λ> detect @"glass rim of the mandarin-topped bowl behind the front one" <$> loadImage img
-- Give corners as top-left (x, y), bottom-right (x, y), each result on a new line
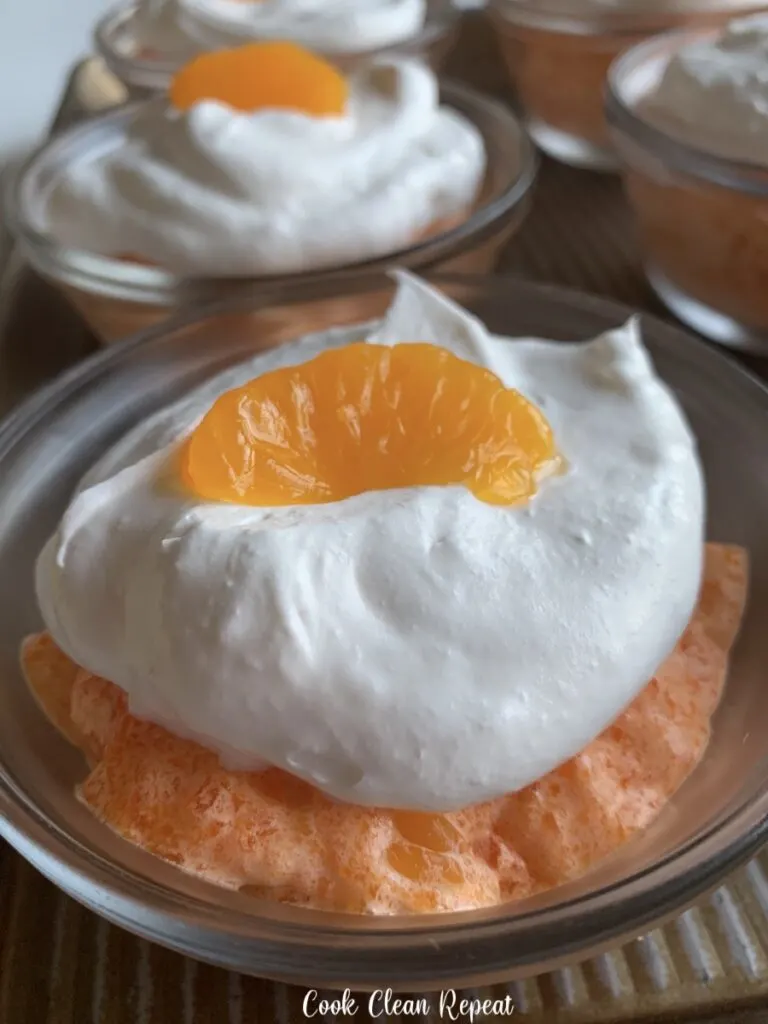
top-left (4, 79), bottom-right (539, 306)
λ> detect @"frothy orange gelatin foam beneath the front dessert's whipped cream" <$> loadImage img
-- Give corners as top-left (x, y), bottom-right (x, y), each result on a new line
top-left (22, 545), bottom-right (748, 913)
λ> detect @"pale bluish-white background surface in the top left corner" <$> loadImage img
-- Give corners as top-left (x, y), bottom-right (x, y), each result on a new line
top-left (0, 0), bottom-right (109, 166)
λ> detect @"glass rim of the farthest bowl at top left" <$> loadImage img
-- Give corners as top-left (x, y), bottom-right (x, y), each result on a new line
top-left (93, 0), bottom-right (462, 89)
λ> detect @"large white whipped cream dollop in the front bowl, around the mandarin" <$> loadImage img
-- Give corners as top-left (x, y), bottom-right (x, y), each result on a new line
top-left (37, 276), bottom-right (703, 810)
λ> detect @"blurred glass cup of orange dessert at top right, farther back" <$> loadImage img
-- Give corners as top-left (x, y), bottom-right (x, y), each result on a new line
top-left (490, 0), bottom-right (760, 171)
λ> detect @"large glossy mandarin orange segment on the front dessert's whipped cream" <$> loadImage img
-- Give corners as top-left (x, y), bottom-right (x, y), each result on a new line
top-left (181, 342), bottom-right (555, 506)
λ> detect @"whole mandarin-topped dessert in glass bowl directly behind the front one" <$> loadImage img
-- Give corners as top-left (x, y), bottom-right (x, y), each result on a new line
top-left (6, 44), bottom-right (537, 341)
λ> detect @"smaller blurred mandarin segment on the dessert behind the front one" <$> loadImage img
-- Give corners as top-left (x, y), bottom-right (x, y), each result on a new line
top-left (170, 42), bottom-right (348, 118)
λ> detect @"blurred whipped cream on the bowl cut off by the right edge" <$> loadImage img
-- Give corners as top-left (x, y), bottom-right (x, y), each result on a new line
top-left (639, 13), bottom-right (768, 167)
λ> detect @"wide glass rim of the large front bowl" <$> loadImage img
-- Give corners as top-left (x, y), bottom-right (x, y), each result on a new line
top-left (0, 274), bottom-right (768, 987)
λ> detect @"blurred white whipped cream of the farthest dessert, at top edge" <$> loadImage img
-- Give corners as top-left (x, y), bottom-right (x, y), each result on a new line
top-left (135, 0), bottom-right (427, 55)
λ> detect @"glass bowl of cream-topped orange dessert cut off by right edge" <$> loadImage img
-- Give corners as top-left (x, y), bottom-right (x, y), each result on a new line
top-left (606, 15), bottom-right (768, 355)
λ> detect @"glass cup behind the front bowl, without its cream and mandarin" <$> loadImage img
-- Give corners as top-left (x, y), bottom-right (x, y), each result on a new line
top-left (6, 83), bottom-right (538, 342)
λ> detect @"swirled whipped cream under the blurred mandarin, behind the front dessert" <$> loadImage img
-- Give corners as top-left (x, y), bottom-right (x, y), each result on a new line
top-left (44, 58), bottom-right (485, 276)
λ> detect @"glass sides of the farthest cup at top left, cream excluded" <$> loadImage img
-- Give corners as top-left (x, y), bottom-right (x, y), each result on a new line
top-left (93, 0), bottom-right (461, 98)
